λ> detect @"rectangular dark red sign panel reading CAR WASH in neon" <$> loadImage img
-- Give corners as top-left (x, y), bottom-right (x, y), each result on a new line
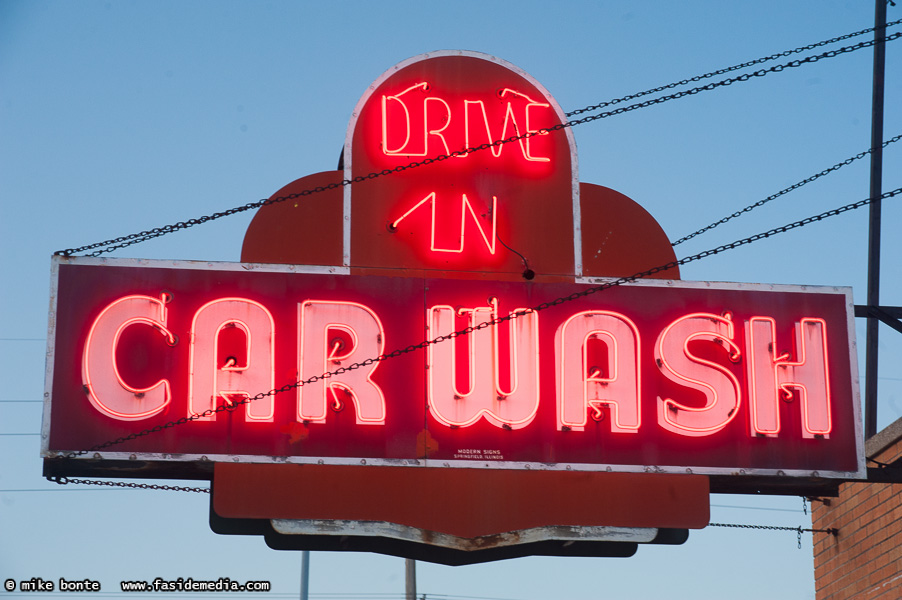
top-left (44, 258), bottom-right (863, 477)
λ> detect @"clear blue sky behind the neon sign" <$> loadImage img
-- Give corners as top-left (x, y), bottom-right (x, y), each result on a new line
top-left (0, 0), bottom-right (902, 600)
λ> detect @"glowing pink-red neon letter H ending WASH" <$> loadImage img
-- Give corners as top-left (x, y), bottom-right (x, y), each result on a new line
top-left (746, 317), bottom-right (832, 438)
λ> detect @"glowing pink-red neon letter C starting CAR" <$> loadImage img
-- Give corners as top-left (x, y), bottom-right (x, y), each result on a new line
top-left (81, 294), bottom-right (176, 421)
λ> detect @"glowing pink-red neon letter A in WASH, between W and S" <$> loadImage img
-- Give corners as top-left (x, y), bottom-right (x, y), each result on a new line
top-left (554, 310), bottom-right (641, 433)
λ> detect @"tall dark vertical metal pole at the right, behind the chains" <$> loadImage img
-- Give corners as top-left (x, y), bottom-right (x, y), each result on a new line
top-left (864, 0), bottom-right (886, 438)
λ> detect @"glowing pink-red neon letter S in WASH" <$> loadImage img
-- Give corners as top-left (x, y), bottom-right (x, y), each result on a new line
top-left (655, 313), bottom-right (741, 436)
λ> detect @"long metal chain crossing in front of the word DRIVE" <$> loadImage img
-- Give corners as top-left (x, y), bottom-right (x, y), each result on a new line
top-left (55, 28), bottom-right (902, 257)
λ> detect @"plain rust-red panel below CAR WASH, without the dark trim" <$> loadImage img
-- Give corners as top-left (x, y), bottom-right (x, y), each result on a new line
top-left (213, 463), bottom-right (709, 539)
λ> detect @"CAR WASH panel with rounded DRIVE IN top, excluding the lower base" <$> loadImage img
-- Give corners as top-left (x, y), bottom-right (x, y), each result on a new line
top-left (43, 51), bottom-right (864, 478)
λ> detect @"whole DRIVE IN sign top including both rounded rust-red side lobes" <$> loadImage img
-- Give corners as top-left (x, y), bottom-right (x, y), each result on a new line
top-left (241, 50), bottom-right (680, 282)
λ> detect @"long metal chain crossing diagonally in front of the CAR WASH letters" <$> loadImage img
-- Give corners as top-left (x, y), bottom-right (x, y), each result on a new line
top-left (51, 188), bottom-right (902, 458)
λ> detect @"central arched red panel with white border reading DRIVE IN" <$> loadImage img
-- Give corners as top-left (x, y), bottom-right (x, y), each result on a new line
top-left (343, 50), bottom-right (582, 277)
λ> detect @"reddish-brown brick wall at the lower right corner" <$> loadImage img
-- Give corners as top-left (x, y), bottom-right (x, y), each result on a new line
top-left (812, 419), bottom-right (902, 600)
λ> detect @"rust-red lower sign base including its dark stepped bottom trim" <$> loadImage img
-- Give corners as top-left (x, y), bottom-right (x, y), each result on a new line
top-left (210, 464), bottom-right (708, 565)
